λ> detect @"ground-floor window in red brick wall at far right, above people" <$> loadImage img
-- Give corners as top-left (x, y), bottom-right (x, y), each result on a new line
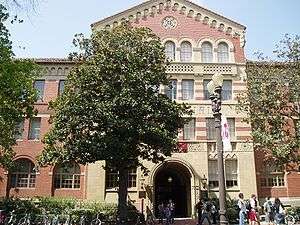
top-left (260, 165), bottom-right (285, 187)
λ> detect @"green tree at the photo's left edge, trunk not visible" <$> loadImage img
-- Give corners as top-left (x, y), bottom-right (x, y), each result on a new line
top-left (0, 4), bottom-right (39, 167)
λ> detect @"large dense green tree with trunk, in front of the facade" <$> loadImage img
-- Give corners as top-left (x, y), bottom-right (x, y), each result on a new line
top-left (40, 25), bottom-right (191, 223)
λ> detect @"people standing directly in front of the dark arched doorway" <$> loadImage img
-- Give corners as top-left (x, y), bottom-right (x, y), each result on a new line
top-left (158, 199), bottom-right (175, 225)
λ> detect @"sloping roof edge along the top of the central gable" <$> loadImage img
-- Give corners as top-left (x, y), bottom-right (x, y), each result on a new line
top-left (90, 0), bottom-right (247, 30)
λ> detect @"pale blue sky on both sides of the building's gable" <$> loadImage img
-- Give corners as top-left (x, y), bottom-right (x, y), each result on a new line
top-left (5, 0), bottom-right (300, 59)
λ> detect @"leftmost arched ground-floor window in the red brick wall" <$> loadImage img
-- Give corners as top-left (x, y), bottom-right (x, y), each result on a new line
top-left (10, 159), bottom-right (36, 188)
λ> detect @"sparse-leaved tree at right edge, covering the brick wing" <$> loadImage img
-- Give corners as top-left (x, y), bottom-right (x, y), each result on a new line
top-left (239, 35), bottom-right (300, 165)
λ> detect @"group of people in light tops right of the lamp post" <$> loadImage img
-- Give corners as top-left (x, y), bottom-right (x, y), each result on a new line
top-left (238, 193), bottom-right (285, 225)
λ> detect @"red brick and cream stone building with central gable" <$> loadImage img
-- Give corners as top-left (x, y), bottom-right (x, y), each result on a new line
top-left (0, 0), bottom-right (300, 217)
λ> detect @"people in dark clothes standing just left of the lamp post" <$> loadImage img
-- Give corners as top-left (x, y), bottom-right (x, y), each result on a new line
top-left (196, 199), bottom-right (218, 225)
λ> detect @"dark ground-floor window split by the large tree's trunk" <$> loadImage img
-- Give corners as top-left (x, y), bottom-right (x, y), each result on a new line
top-left (105, 168), bottom-right (137, 189)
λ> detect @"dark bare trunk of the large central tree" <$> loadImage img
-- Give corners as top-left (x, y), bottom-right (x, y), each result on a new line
top-left (117, 167), bottom-right (128, 225)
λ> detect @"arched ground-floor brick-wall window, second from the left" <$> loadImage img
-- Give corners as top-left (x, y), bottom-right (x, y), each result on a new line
top-left (54, 163), bottom-right (81, 189)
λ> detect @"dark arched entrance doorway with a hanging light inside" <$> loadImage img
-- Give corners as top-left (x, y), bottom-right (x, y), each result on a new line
top-left (154, 162), bottom-right (191, 218)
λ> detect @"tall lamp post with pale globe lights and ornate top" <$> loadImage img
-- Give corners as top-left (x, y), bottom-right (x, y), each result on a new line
top-left (207, 74), bottom-right (228, 225)
